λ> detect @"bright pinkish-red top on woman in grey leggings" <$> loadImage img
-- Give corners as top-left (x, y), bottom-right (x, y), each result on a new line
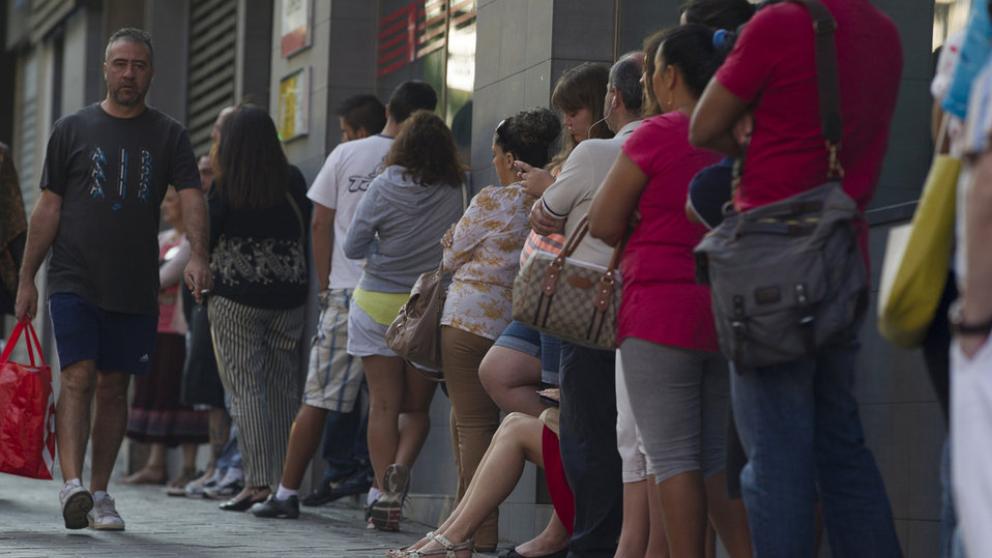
top-left (617, 112), bottom-right (720, 352)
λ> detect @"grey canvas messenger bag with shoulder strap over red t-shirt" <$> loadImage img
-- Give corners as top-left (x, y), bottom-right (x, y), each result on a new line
top-left (695, 0), bottom-right (868, 369)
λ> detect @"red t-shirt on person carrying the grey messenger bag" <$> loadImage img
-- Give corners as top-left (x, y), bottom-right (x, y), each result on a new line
top-left (716, 0), bottom-right (902, 221)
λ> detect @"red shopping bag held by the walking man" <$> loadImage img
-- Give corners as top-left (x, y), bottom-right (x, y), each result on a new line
top-left (0, 321), bottom-right (55, 480)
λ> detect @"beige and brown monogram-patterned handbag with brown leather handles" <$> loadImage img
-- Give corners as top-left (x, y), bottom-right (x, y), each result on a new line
top-left (513, 218), bottom-right (623, 350)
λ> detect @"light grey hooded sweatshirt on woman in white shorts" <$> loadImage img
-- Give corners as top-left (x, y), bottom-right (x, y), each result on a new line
top-left (344, 165), bottom-right (462, 293)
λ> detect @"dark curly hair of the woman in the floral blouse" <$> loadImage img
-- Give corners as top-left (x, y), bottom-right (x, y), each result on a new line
top-left (493, 108), bottom-right (561, 168)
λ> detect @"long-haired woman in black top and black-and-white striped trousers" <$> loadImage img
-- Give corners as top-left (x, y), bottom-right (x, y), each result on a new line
top-left (202, 106), bottom-right (310, 511)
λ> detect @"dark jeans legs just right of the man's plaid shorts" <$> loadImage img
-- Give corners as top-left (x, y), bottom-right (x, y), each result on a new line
top-left (321, 382), bottom-right (372, 482)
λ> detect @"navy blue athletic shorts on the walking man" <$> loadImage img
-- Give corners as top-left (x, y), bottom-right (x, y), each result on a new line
top-left (48, 293), bottom-right (158, 374)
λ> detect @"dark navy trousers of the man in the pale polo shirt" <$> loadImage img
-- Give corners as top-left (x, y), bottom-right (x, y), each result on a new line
top-left (560, 341), bottom-right (623, 558)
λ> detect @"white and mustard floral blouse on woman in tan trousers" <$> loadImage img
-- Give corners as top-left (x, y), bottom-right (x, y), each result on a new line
top-left (441, 184), bottom-right (534, 340)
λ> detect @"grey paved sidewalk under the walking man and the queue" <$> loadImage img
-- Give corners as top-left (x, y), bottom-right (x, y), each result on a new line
top-left (0, 475), bottom-right (429, 558)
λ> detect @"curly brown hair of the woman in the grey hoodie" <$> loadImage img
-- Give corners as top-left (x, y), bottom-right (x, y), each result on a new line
top-left (385, 110), bottom-right (465, 187)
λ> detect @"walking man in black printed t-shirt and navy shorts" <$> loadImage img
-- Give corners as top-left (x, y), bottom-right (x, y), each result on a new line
top-left (15, 28), bottom-right (211, 530)
